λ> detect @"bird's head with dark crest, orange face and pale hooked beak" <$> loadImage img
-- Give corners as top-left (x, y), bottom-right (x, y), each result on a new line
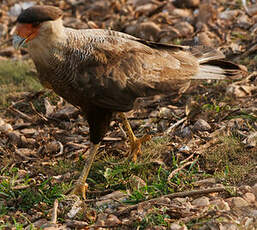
top-left (13, 6), bottom-right (63, 49)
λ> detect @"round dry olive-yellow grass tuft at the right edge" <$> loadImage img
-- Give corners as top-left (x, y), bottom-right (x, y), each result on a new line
top-left (201, 136), bottom-right (257, 185)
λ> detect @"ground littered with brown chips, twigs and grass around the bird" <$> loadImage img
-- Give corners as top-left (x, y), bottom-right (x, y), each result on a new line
top-left (0, 0), bottom-right (257, 230)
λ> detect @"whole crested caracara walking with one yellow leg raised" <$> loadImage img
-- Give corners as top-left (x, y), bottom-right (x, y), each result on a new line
top-left (13, 6), bottom-right (243, 198)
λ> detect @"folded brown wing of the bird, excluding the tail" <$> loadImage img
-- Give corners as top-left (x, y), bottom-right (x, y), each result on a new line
top-left (73, 30), bottom-right (199, 111)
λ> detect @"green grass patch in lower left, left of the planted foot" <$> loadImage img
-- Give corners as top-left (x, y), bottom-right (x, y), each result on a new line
top-left (0, 168), bottom-right (69, 217)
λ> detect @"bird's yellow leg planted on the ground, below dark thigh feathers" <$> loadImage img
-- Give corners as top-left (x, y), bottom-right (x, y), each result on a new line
top-left (71, 143), bottom-right (100, 199)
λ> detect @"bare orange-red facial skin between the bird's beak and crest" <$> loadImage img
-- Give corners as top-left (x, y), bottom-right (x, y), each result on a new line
top-left (16, 23), bottom-right (40, 42)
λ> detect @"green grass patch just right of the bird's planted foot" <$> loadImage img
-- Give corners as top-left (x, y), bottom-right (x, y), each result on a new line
top-left (86, 136), bottom-right (199, 204)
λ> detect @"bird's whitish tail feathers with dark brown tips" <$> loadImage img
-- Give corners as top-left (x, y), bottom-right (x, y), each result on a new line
top-left (191, 47), bottom-right (246, 80)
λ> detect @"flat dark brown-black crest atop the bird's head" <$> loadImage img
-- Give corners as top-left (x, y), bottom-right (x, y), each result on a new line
top-left (17, 6), bottom-right (62, 23)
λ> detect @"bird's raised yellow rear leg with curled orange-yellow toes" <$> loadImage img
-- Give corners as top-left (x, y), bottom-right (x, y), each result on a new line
top-left (120, 113), bottom-right (151, 162)
